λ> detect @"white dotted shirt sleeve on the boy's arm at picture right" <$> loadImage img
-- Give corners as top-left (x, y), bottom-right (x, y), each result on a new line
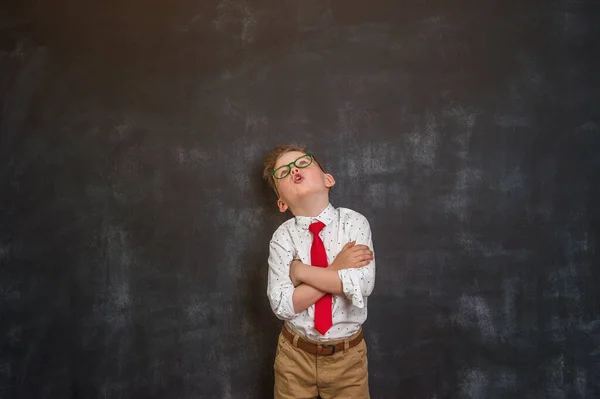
top-left (338, 218), bottom-right (375, 308)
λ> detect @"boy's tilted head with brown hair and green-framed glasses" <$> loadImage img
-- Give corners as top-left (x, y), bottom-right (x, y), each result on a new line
top-left (263, 144), bottom-right (335, 216)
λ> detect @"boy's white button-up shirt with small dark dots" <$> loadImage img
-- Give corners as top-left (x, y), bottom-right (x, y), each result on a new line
top-left (267, 204), bottom-right (375, 341)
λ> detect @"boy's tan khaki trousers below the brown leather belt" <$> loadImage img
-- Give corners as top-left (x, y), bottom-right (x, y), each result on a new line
top-left (274, 324), bottom-right (370, 399)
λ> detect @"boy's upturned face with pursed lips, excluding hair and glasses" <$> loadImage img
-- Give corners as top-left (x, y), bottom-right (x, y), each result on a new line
top-left (275, 151), bottom-right (335, 212)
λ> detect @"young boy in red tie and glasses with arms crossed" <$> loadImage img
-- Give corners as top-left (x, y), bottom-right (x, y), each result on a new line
top-left (263, 145), bottom-right (375, 399)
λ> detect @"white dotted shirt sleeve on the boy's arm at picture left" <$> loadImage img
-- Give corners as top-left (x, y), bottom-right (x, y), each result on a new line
top-left (267, 230), bottom-right (296, 320)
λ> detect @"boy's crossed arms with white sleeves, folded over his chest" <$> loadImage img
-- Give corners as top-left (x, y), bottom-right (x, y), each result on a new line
top-left (267, 221), bottom-right (375, 320)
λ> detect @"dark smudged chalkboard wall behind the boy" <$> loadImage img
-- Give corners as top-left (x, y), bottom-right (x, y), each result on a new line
top-left (0, 0), bottom-right (600, 399)
